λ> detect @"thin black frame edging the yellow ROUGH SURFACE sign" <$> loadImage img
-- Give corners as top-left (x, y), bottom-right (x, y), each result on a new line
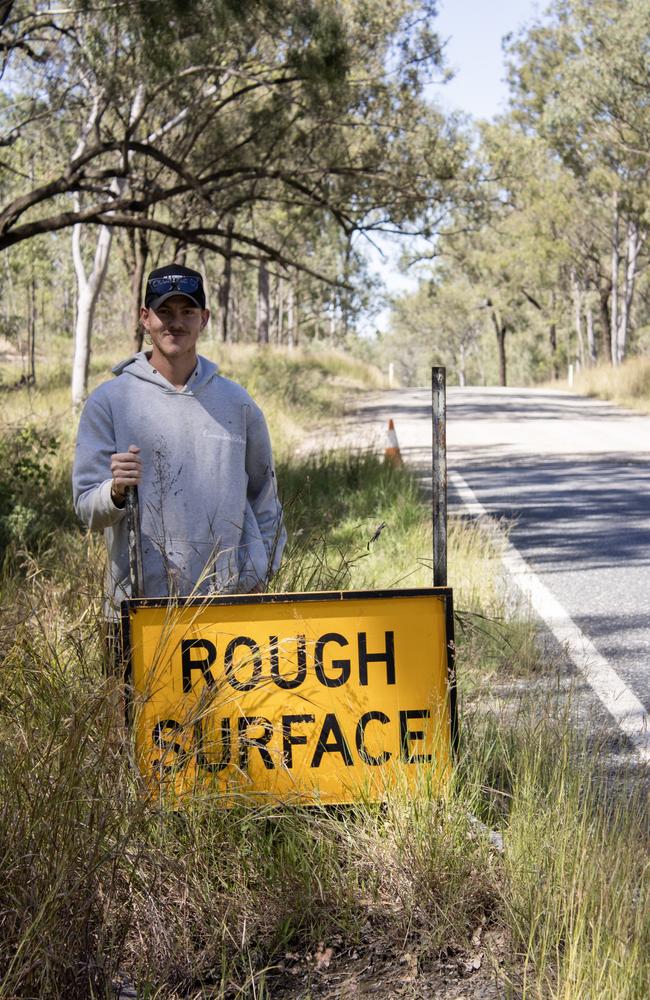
top-left (120, 587), bottom-right (459, 796)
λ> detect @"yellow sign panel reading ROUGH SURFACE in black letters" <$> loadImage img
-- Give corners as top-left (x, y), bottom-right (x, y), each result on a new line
top-left (122, 588), bottom-right (456, 805)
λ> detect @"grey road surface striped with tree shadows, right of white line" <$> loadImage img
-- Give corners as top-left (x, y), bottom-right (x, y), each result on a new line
top-left (350, 388), bottom-right (650, 752)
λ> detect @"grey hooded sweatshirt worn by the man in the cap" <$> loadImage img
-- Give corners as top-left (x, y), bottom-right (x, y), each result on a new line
top-left (72, 353), bottom-right (286, 617)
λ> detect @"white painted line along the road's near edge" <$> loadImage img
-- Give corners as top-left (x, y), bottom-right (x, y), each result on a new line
top-left (449, 472), bottom-right (650, 762)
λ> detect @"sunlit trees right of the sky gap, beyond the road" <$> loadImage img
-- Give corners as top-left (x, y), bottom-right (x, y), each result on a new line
top-left (388, 0), bottom-right (650, 384)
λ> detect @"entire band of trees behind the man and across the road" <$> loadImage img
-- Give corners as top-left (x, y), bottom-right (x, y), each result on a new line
top-left (0, 0), bottom-right (650, 398)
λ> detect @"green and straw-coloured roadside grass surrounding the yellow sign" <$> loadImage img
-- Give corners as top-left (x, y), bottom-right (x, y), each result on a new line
top-left (0, 346), bottom-right (650, 1000)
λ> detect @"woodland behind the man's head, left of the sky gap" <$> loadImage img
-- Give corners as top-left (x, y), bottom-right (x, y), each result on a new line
top-left (0, 0), bottom-right (466, 406)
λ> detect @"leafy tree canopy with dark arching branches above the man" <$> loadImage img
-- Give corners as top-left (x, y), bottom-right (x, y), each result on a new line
top-left (0, 0), bottom-right (464, 402)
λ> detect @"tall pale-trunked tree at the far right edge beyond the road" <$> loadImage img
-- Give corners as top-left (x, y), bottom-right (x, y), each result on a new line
top-left (509, 0), bottom-right (650, 364)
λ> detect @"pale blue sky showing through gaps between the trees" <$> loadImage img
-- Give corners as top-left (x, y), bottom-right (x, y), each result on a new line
top-left (368, 0), bottom-right (546, 329)
